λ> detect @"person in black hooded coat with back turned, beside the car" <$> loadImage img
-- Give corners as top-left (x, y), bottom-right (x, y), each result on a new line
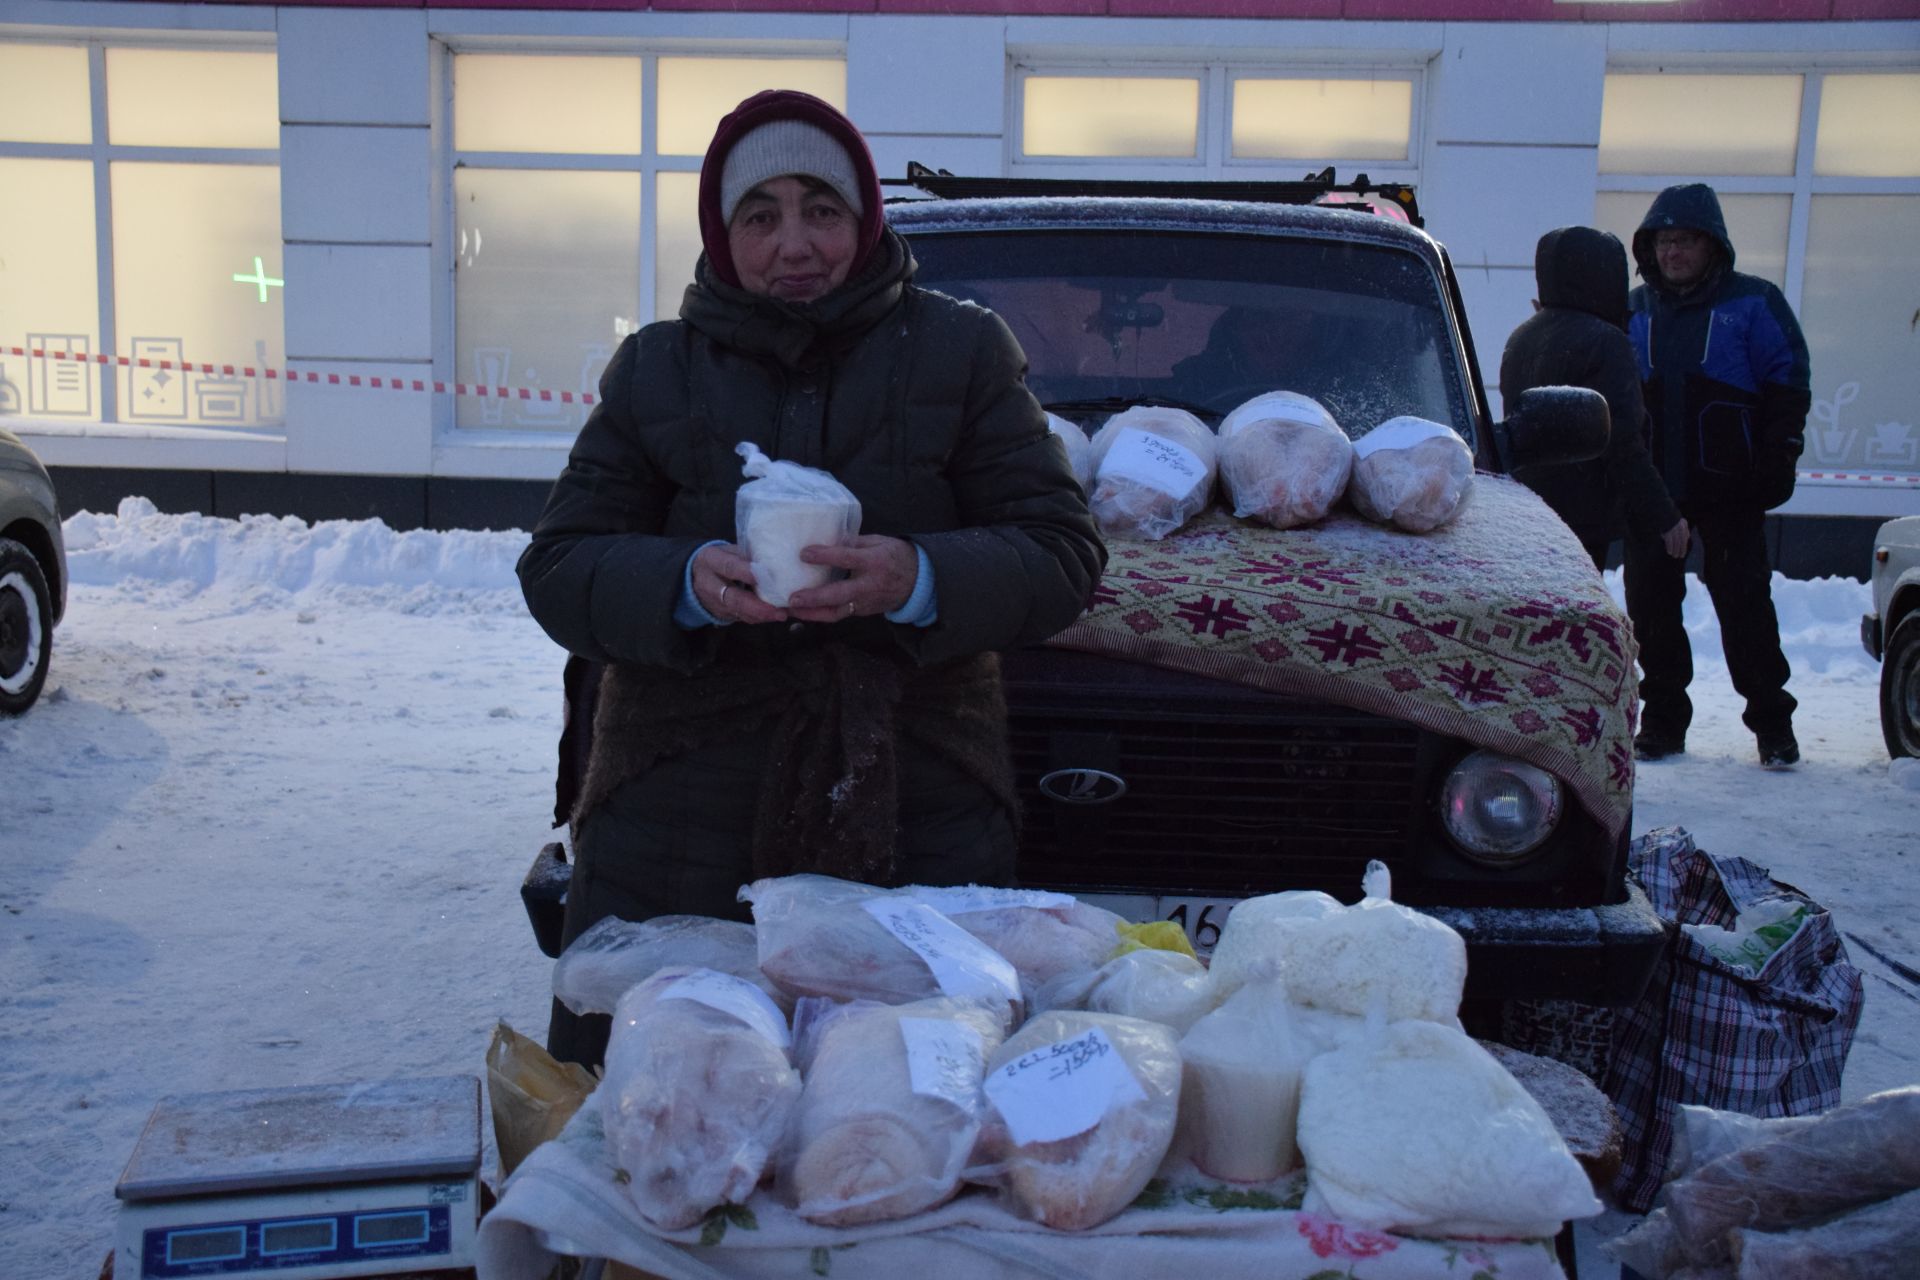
top-left (1500, 226), bottom-right (1688, 568)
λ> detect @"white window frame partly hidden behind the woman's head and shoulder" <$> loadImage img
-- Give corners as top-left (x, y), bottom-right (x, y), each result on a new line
top-left (434, 35), bottom-right (847, 445)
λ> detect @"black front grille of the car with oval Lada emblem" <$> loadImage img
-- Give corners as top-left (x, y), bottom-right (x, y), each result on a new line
top-left (1006, 651), bottom-right (1427, 896)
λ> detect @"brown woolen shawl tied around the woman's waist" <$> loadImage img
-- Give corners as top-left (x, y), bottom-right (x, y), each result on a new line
top-left (570, 643), bottom-right (1020, 885)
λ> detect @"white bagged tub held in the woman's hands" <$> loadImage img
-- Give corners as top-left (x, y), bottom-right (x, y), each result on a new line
top-left (733, 441), bottom-right (860, 608)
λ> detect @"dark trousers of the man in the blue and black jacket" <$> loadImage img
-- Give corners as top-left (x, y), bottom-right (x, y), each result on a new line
top-left (1624, 507), bottom-right (1797, 739)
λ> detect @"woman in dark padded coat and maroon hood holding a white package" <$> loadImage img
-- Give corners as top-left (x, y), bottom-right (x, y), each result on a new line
top-left (518, 90), bottom-right (1106, 1063)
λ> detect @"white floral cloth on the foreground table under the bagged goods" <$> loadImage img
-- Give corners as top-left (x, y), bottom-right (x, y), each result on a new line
top-left (478, 1094), bottom-right (1565, 1280)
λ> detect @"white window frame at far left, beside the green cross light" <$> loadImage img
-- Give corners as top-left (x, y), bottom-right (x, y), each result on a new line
top-left (0, 35), bottom-right (286, 429)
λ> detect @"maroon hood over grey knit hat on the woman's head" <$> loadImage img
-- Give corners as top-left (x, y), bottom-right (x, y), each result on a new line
top-left (699, 88), bottom-right (883, 286)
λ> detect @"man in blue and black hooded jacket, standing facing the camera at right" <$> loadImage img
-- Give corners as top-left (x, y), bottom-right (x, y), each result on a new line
top-left (1624, 182), bottom-right (1812, 770)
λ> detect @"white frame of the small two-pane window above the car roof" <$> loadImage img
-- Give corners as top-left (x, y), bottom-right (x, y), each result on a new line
top-left (1006, 56), bottom-right (1427, 182)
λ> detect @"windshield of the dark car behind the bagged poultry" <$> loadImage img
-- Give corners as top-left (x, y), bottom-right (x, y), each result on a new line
top-left (914, 230), bottom-right (1473, 443)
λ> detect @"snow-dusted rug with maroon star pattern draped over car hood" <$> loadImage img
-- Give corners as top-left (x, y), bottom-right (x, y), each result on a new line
top-left (1048, 474), bottom-right (1636, 835)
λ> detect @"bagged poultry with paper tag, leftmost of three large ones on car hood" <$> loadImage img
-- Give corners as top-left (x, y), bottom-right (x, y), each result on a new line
top-left (1087, 405), bottom-right (1219, 541)
